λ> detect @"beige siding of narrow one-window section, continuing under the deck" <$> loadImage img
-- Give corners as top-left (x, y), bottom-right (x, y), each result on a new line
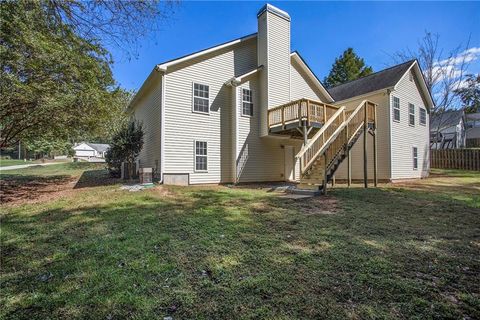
top-left (235, 77), bottom-right (285, 182)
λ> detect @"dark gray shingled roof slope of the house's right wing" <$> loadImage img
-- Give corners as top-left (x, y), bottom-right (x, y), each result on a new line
top-left (327, 60), bottom-right (415, 101)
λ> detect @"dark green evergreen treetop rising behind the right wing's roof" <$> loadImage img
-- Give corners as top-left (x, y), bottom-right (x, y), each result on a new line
top-left (323, 48), bottom-right (373, 88)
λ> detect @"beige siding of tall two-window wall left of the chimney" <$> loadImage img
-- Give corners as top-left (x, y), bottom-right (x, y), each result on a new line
top-left (165, 38), bottom-right (257, 184)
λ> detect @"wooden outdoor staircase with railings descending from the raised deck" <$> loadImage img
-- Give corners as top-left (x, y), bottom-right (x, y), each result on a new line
top-left (297, 100), bottom-right (376, 194)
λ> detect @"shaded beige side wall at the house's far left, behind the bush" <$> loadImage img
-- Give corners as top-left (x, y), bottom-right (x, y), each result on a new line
top-left (134, 76), bottom-right (162, 177)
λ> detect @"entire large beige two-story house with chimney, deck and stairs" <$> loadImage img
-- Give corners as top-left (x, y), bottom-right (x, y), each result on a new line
top-left (128, 4), bottom-right (433, 190)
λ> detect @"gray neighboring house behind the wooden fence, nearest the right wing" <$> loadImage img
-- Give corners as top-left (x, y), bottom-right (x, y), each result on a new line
top-left (430, 110), bottom-right (466, 149)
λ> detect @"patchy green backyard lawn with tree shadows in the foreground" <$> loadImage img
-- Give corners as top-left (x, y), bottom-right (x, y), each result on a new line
top-left (0, 164), bottom-right (480, 319)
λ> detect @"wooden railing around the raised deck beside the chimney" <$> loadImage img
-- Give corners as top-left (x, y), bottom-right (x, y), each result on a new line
top-left (268, 99), bottom-right (339, 128)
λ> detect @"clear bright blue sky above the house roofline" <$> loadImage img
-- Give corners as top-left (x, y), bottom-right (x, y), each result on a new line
top-left (112, 1), bottom-right (480, 90)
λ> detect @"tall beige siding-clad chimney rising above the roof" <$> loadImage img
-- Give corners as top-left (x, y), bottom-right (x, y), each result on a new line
top-left (257, 4), bottom-right (290, 136)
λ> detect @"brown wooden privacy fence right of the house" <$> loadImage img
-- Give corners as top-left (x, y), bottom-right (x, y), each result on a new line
top-left (430, 149), bottom-right (480, 171)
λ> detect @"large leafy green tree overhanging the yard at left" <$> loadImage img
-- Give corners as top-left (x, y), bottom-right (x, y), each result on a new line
top-left (0, 0), bottom-right (176, 148)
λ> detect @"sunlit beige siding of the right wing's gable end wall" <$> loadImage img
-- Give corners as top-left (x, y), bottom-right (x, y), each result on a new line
top-left (390, 73), bottom-right (429, 179)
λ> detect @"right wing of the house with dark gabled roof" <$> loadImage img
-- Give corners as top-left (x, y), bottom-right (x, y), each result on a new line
top-left (329, 60), bottom-right (434, 181)
